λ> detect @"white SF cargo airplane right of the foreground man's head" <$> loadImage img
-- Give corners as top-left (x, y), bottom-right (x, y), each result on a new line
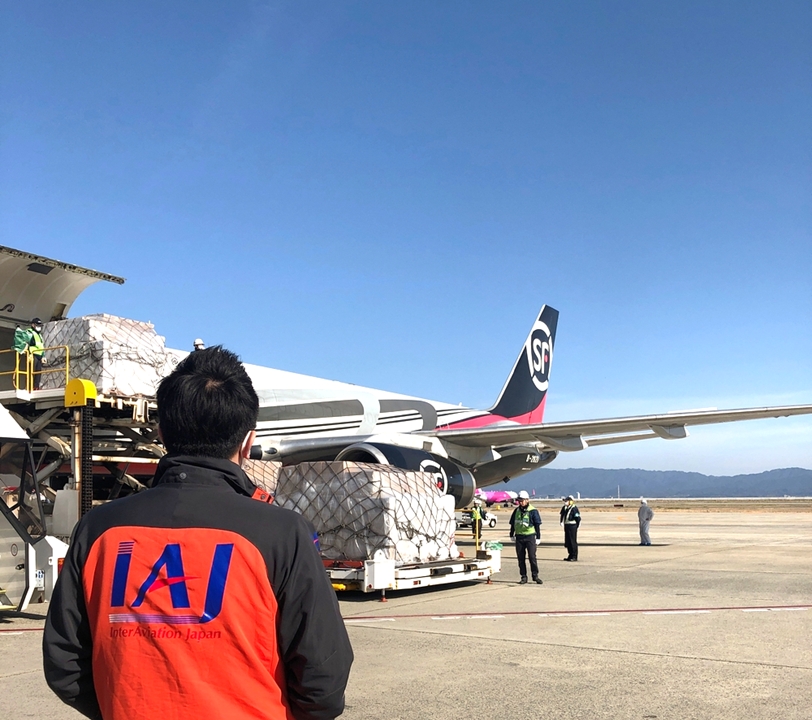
top-left (245, 305), bottom-right (812, 509)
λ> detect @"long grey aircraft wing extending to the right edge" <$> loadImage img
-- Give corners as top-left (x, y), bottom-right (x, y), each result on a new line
top-left (422, 405), bottom-right (812, 452)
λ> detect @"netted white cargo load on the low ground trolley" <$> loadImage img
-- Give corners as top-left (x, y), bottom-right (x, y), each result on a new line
top-left (275, 462), bottom-right (459, 565)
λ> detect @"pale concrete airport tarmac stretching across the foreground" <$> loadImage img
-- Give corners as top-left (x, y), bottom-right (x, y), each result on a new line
top-left (0, 510), bottom-right (812, 720)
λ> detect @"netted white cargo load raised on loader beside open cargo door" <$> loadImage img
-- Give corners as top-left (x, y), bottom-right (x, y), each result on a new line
top-left (42, 314), bottom-right (178, 397)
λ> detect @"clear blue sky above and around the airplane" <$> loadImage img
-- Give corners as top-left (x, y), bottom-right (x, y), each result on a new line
top-left (0, 0), bottom-right (812, 474)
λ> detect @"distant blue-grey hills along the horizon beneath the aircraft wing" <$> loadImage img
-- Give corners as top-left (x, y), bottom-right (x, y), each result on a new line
top-left (502, 468), bottom-right (812, 498)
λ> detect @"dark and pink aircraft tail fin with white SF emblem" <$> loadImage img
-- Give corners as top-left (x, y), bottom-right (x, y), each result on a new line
top-left (488, 305), bottom-right (558, 424)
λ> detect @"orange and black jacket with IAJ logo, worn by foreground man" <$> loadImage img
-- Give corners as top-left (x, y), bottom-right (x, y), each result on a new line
top-left (43, 455), bottom-right (353, 720)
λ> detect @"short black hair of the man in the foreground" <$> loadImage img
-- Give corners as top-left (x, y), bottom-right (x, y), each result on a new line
top-left (157, 345), bottom-right (259, 459)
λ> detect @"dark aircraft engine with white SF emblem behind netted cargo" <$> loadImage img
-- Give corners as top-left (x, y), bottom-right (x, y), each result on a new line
top-left (336, 443), bottom-right (476, 509)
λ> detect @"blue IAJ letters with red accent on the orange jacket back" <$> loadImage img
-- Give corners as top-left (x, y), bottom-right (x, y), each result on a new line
top-left (110, 542), bottom-right (234, 625)
